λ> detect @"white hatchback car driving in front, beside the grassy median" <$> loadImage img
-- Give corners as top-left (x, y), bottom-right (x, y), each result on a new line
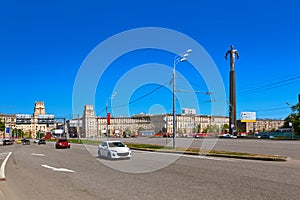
top-left (98, 141), bottom-right (131, 159)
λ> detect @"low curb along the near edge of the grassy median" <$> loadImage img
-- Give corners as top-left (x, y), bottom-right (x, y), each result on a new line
top-left (130, 148), bottom-right (288, 162)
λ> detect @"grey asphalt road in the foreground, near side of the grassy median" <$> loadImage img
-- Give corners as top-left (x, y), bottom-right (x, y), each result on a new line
top-left (0, 140), bottom-right (300, 200)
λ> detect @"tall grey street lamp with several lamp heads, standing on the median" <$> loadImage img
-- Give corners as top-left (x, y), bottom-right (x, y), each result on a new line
top-left (173, 49), bottom-right (192, 149)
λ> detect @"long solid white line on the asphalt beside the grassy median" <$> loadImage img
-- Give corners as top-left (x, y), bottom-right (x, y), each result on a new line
top-left (132, 150), bottom-right (238, 162)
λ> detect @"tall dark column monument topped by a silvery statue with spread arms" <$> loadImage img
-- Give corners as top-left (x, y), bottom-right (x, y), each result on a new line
top-left (225, 45), bottom-right (240, 134)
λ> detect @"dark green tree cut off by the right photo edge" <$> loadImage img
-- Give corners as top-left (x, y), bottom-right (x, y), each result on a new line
top-left (283, 103), bottom-right (300, 135)
